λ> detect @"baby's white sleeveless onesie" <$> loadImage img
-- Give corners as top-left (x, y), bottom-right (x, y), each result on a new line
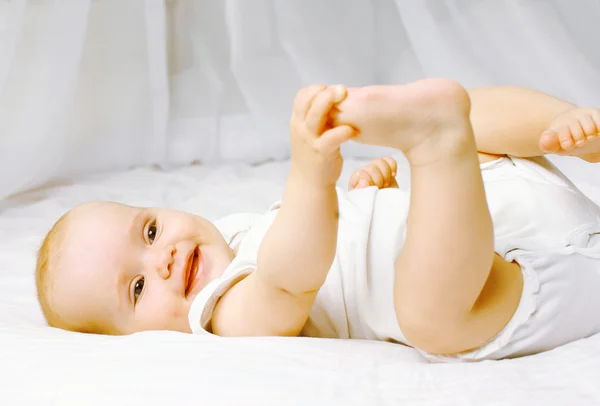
top-left (189, 157), bottom-right (600, 361)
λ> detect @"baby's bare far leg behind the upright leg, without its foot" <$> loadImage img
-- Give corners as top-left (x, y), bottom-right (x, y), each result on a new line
top-left (469, 86), bottom-right (576, 157)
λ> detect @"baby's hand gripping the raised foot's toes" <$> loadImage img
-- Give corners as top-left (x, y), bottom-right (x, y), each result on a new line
top-left (290, 85), bottom-right (355, 186)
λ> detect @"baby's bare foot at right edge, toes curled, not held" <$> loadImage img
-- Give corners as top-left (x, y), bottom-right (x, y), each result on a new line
top-left (539, 108), bottom-right (600, 162)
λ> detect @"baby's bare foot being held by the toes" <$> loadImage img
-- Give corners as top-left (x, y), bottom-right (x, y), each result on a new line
top-left (332, 79), bottom-right (472, 164)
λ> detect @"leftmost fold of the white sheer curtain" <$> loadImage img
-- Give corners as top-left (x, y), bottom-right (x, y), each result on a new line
top-left (0, 0), bottom-right (90, 196)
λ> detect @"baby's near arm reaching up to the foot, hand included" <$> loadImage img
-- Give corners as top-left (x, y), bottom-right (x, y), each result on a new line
top-left (212, 86), bottom-right (354, 336)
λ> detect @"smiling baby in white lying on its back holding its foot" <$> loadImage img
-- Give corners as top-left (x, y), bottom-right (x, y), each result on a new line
top-left (36, 79), bottom-right (600, 361)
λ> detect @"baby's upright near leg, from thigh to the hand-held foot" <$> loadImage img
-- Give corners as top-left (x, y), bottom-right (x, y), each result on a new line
top-left (334, 79), bottom-right (522, 353)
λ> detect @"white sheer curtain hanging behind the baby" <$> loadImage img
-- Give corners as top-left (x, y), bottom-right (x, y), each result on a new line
top-left (0, 0), bottom-right (600, 198)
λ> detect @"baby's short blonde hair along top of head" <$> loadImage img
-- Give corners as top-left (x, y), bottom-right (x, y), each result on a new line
top-left (35, 212), bottom-right (77, 330)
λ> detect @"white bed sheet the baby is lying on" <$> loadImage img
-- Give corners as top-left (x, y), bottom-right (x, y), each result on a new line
top-left (0, 156), bottom-right (600, 406)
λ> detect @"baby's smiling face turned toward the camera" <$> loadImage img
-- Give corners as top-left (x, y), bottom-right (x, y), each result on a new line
top-left (51, 202), bottom-right (234, 334)
